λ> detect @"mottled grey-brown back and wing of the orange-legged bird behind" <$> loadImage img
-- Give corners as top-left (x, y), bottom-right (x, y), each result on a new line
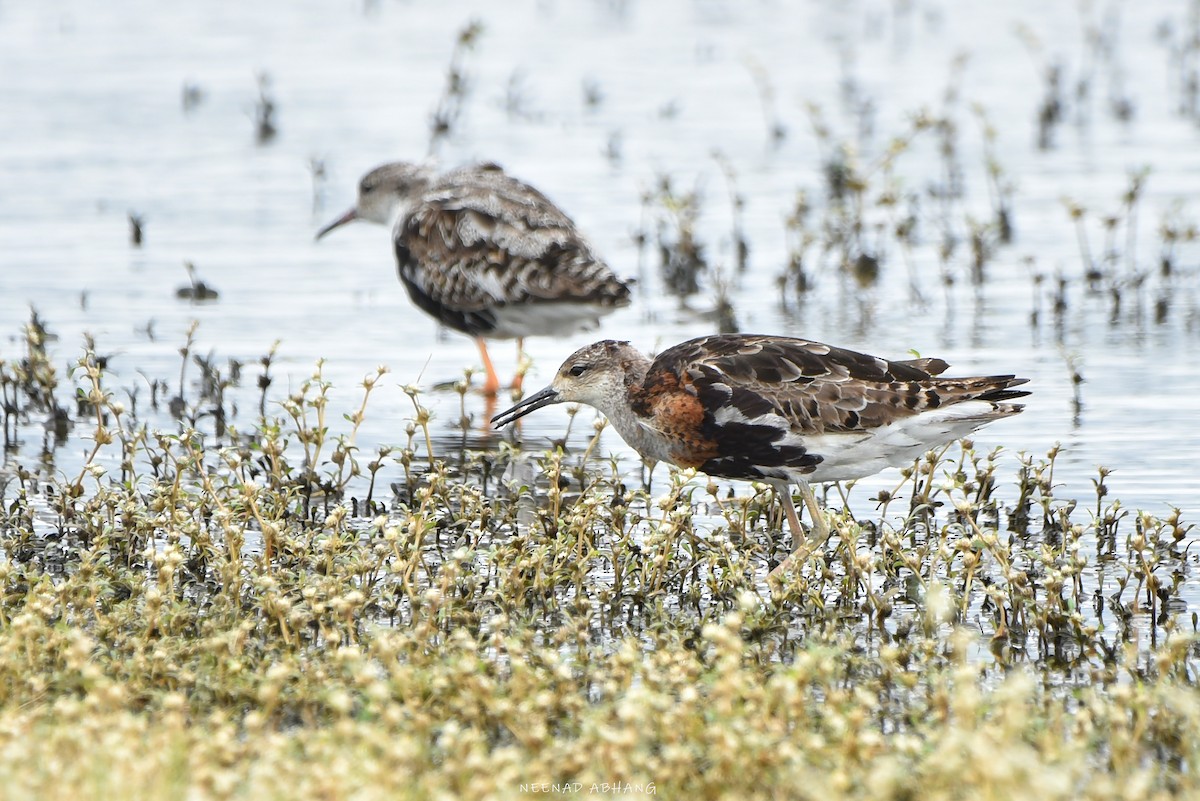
top-left (397, 164), bottom-right (629, 311)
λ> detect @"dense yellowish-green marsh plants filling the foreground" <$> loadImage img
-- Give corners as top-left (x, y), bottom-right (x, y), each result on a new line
top-left (0, 321), bottom-right (1200, 799)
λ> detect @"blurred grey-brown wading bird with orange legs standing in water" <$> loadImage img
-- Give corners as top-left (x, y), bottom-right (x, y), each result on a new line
top-left (317, 162), bottom-right (630, 395)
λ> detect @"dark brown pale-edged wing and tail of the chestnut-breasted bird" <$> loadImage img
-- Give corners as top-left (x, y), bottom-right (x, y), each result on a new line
top-left (637, 335), bottom-right (1027, 478)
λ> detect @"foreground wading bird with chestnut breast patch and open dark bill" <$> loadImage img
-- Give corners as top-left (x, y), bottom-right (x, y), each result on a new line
top-left (492, 335), bottom-right (1028, 574)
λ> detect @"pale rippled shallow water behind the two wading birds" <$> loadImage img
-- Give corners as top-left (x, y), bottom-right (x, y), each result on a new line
top-left (0, 0), bottom-right (1200, 520)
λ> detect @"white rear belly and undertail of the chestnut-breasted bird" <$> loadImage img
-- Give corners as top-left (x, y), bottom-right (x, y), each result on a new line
top-left (797, 401), bottom-right (997, 482)
